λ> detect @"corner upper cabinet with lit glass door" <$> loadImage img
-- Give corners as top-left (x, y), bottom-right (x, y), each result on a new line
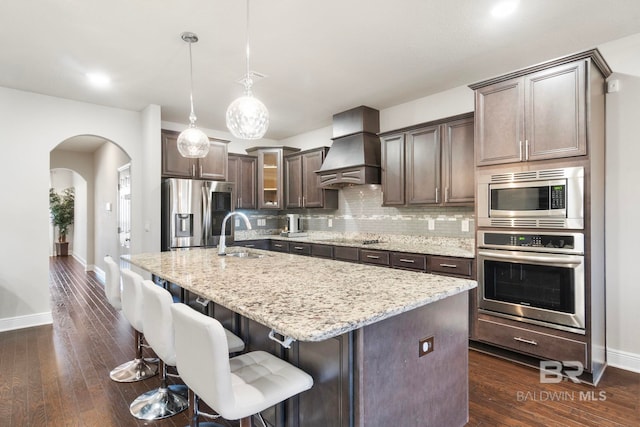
top-left (246, 147), bottom-right (300, 209)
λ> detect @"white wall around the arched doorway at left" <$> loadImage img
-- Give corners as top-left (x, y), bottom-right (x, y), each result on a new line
top-left (0, 87), bottom-right (160, 330)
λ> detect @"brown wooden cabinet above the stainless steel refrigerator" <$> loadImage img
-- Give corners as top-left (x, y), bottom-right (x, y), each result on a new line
top-left (162, 130), bottom-right (229, 181)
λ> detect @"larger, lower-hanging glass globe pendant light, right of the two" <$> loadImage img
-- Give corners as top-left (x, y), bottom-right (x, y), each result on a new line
top-left (227, 0), bottom-right (269, 139)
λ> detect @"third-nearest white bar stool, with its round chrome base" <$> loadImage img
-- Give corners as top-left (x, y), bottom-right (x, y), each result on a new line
top-left (109, 268), bottom-right (158, 383)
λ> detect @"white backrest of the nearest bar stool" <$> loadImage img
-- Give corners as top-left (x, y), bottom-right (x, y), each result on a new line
top-left (171, 303), bottom-right (236, 412)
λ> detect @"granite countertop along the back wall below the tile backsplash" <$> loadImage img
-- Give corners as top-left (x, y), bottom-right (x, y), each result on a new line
top-left (235, 231), bottom-right (475, 259)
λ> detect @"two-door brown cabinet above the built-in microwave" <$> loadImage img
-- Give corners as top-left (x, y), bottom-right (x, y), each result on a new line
top-left (470, 51), bottom-right (607, 166)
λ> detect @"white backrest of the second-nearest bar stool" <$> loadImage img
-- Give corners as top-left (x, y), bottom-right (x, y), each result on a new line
top-left (142, 280), bottom-right (176, 366)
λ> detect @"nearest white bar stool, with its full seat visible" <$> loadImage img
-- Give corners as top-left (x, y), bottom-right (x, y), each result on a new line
top-left (171, 303), bottom-right (313, 427)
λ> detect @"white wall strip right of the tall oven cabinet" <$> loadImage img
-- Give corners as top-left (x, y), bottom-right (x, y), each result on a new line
top-left (600, 34), bottom-right (640, 372)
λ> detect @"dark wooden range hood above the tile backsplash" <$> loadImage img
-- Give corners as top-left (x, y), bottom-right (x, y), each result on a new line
top-left (315, 106), bottom-right (380, 188)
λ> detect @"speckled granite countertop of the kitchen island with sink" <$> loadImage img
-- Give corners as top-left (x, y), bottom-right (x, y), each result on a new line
top-left (123, 247), bottom-right (476, 341)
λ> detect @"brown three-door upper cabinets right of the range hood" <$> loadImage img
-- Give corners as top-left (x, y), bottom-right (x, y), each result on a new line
top-left (381, 114), bottom-right (474, 206)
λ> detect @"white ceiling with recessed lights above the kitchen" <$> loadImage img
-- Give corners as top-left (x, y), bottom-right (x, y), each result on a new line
top-left (0, 0), bottom-right (640, 145)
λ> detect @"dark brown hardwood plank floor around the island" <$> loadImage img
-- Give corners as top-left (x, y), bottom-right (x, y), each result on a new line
top-left (0, 257), bottom-right (640, 427)
